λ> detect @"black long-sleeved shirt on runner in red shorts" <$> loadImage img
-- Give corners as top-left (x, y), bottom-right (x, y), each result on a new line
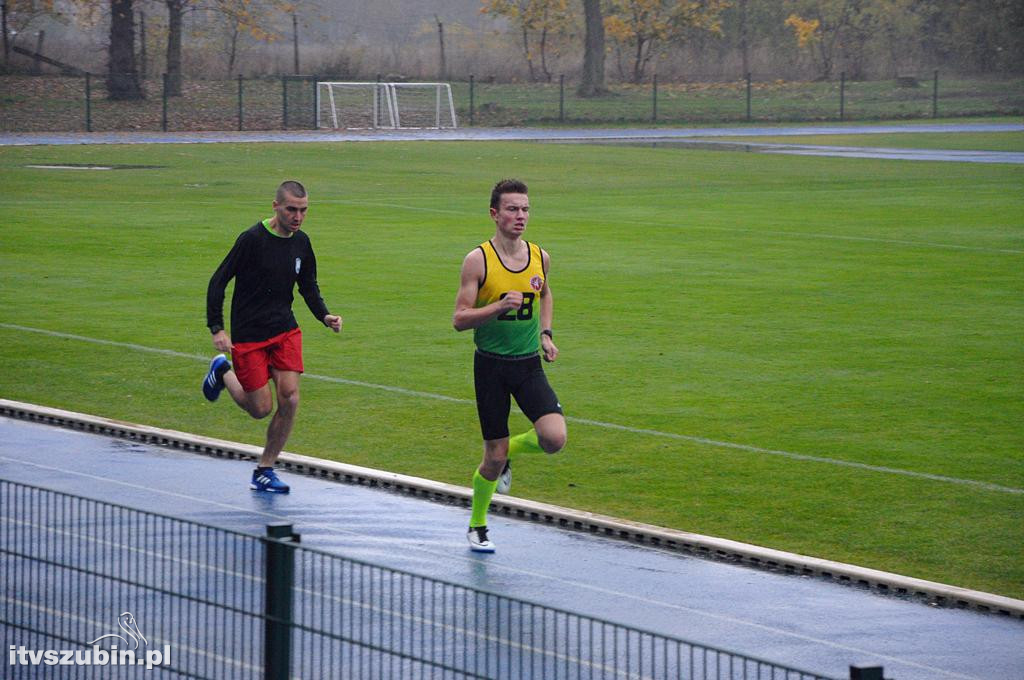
top-left (206, 222), bottom-right (330, 342)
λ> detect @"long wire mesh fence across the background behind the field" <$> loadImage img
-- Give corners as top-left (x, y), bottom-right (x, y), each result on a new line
top-left (0, 72), bottom-right (1024, 132)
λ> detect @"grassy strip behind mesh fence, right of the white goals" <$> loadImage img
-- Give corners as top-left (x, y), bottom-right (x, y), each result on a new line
top-left (462, 76), bottom-right (1024, 125)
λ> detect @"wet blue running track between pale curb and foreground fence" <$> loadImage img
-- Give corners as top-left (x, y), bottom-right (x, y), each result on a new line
top-left (0, 417), bottom-right (1024, 680)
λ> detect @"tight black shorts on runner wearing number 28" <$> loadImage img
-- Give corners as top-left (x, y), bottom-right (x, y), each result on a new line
top-left (473, 350), bottom-right (562, 439)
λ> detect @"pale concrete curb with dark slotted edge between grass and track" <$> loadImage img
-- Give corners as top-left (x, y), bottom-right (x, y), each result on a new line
top-left (0, 399), bottom-right (1024, 619)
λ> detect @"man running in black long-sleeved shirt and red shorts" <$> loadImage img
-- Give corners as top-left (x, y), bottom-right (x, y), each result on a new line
top-left (203, 181), bottom-right (341, 494)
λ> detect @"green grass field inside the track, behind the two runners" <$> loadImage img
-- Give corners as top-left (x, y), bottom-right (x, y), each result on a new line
top-left (0, 135), bottom-right (1024, 597)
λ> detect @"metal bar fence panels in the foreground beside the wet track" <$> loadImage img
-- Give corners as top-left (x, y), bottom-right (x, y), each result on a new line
top-left (0, 480), bottom-right (860, 680)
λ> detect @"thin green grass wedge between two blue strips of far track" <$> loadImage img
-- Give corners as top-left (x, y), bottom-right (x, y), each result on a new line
top-left (715, 132), bottom-right (1024, 152)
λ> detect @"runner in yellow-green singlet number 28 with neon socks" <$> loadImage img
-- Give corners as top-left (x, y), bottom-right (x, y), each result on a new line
top-left (452, 179), bottom-right (566, 552)
